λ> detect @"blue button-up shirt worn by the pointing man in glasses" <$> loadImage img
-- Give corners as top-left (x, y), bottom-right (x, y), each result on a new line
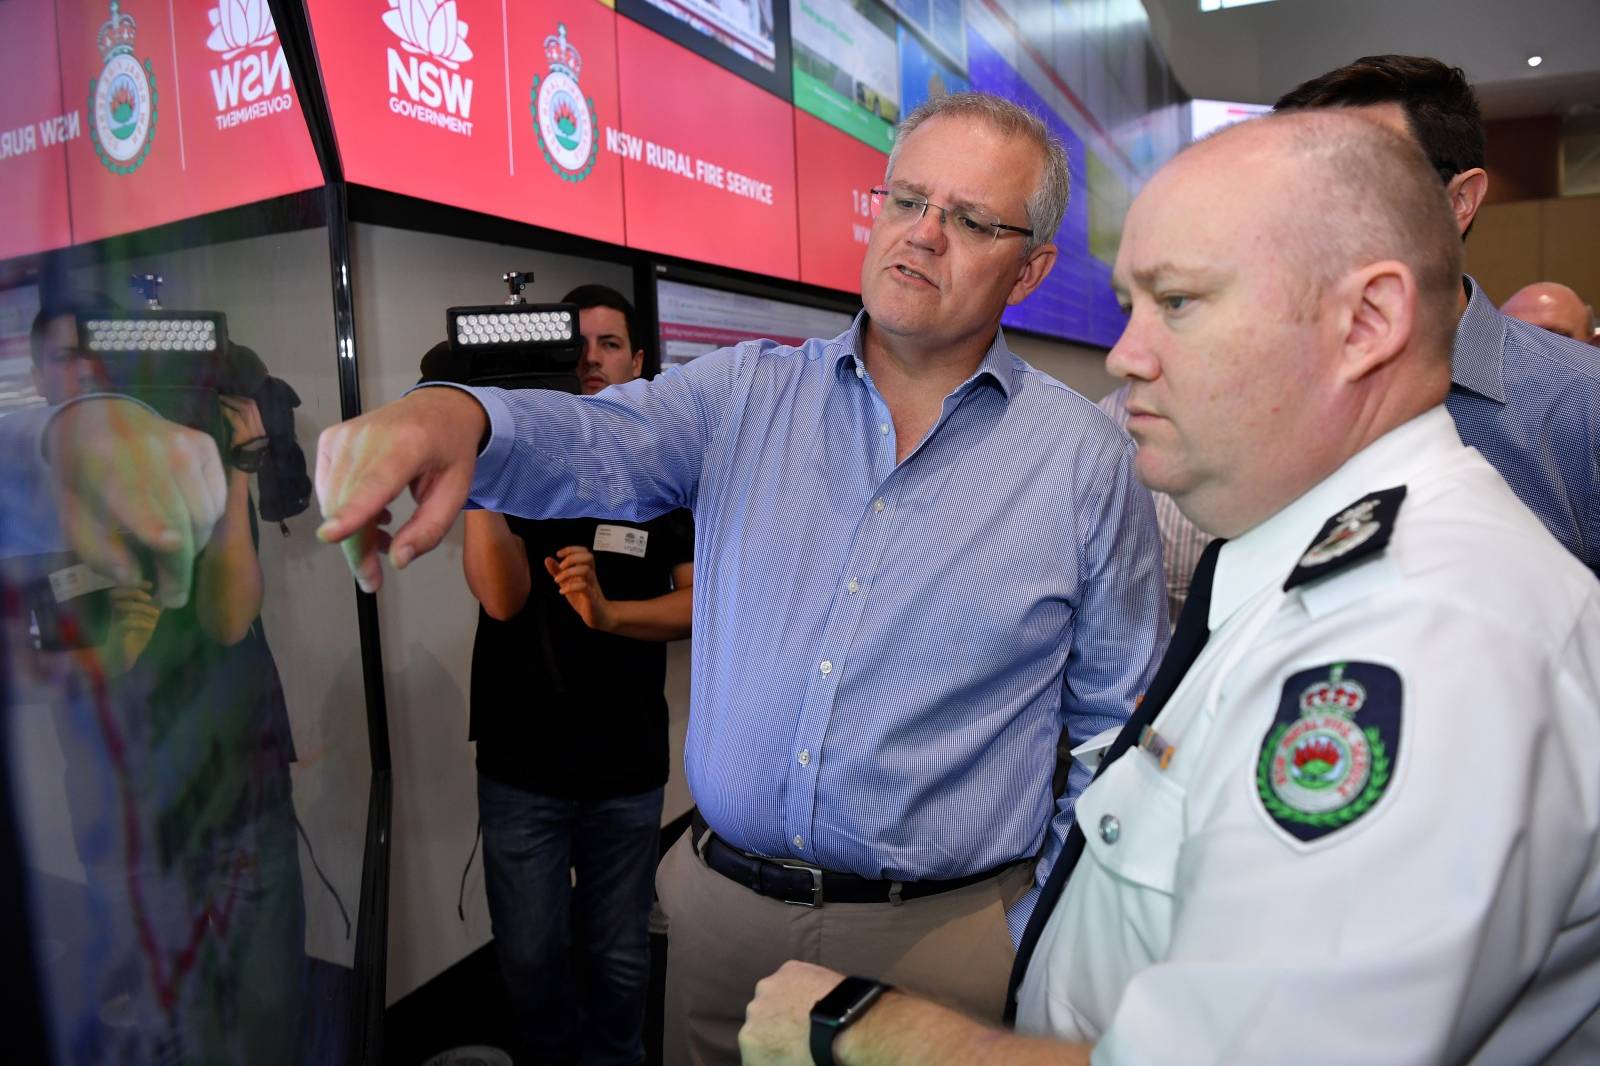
top-left (451, 315), bottom-right (1166, 924)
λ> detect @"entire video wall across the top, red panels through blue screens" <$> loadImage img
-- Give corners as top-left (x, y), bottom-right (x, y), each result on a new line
top-left (0, 0), bottom-right (1186, 344)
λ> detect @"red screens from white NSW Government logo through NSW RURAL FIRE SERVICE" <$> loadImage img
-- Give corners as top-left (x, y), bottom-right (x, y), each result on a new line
top-left (310, 0), bottom-right (812, 279)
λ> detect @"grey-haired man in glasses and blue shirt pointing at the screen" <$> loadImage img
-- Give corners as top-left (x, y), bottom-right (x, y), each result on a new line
top-left (317, 94), bottom-right (1166, 1063)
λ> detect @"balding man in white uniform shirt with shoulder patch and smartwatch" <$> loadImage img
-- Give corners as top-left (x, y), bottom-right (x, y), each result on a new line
top-left (741, 112), bottom-right (1600, 1066)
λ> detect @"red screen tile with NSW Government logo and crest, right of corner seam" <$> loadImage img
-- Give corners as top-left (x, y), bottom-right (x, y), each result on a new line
top-left (310, 0), bottom-right (636, 243)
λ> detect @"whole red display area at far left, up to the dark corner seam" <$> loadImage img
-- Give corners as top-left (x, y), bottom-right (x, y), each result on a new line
top-left (0, 0), bottom-right (322, 259)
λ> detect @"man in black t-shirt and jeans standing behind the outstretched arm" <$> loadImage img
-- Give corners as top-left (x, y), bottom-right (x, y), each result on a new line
top-left (462, 285), bottom-right (694, 1066)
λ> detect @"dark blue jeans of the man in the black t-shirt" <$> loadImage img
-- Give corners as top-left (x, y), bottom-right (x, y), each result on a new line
top-left (478, 773), bottom-right (662, 1066)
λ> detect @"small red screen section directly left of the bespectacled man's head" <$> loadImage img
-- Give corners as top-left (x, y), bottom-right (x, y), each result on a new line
top-left (795, 110), bottom-right (890, 293)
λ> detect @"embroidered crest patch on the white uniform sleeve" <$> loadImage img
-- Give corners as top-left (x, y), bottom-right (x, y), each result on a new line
top-left (1256, 663), bottom-right (1402, 844)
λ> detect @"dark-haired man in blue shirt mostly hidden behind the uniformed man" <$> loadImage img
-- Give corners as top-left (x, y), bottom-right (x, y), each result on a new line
top-left (1275, 56), bottom-right (1600, 575)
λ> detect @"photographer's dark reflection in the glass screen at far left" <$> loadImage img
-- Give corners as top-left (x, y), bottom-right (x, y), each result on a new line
top-left (0, 295), bottom-right (309, 1064)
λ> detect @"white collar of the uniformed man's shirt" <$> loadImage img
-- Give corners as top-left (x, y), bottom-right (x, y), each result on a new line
top-left (1208, 405), bottom-right (1461, 631)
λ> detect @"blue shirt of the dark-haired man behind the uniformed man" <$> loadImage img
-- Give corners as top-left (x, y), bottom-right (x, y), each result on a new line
top-left (1445, 279), bottom-right (1600, 575)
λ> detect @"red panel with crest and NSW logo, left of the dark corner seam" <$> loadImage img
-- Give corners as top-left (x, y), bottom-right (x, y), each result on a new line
top-left (54, 0), bottom-right (322, 243)
